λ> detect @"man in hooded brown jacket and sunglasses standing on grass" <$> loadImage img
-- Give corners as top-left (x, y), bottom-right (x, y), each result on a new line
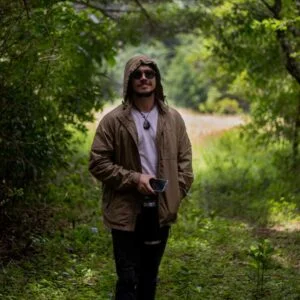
top-left (89, 55), bottom-right (193, 300)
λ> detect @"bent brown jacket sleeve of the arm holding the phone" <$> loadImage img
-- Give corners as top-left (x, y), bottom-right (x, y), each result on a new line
top-left (89, 118), bottom-right (140, 190)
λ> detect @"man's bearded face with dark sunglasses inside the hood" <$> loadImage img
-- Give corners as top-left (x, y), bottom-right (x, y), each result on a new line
top-left (131, 65), bottom-right (156, 97)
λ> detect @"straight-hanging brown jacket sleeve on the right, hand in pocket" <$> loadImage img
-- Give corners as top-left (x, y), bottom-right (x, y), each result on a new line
top-left (177, 116), bottom-right (194, 199)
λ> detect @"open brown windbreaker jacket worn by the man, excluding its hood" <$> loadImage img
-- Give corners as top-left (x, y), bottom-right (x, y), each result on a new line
top-left (89, 55), bottom-right (193, 231)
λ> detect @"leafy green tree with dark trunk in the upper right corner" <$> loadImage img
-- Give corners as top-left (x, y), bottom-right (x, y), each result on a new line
top-left (202, 0), bottom-right (300, 163)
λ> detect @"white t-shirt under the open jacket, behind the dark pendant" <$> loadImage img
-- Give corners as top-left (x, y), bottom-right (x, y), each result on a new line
top-left (131, 106), bottom-right (158, 176)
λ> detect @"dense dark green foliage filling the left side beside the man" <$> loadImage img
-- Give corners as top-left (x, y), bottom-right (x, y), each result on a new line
top-left (0, 1), bottom-right (118, 255)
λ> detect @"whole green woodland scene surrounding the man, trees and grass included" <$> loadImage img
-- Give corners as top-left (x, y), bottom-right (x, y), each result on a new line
top-left (0, 0), bottom-right (300, 300)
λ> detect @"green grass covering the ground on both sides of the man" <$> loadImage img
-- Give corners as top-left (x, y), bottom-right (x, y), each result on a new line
top-left (0, 123), bottom-right (300, 300)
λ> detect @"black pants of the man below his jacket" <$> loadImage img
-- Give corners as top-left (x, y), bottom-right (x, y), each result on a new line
top-left (112, 226), bottom-right (170, 300)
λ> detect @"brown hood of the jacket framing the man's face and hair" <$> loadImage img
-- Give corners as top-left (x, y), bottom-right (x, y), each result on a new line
top-left (123, 55), bottom-right (165, 109)
